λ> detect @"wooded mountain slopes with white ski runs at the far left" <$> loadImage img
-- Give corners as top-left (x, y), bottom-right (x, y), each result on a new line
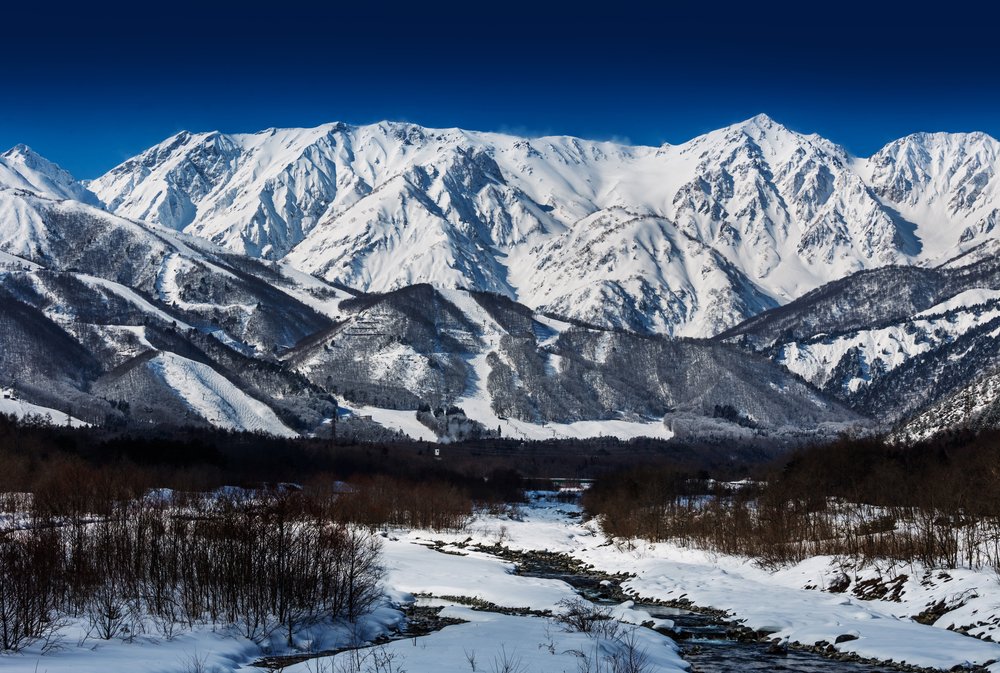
top-left (0, 148), bottom-right (336, 435)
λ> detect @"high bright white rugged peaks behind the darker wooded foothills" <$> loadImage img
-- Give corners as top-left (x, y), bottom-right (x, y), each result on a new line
top-left (90, 115), bottom-right (1000, 337)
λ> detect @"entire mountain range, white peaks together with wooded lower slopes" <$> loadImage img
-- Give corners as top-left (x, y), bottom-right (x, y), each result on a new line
top-left (0, 115), bottom-right (1000, 438)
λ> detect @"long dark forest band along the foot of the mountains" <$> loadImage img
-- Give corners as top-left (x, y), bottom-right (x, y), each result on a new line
top-left (0, 406), bottom-right (772, 490)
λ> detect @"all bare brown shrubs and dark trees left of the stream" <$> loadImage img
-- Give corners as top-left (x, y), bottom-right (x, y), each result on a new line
top-left (0, 416), bottom-right (521, 651)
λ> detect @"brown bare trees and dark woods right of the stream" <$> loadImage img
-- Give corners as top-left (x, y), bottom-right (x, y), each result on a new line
top-left (584, 432), bottom-right (1000, 569)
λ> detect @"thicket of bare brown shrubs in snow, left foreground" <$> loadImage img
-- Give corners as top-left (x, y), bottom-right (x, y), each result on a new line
top-left (0, 484), bottom-right (382, 650)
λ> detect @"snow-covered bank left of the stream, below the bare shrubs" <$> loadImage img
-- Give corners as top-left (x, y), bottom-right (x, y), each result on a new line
top-left (0, 496), bottom-right (689, 673)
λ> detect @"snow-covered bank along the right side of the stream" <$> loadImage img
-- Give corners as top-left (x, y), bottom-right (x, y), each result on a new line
top-left (422, 494), bottom-right (1000, 671)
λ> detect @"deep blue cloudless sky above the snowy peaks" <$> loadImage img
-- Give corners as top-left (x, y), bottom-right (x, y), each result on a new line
top-left (0, 0), bottom-right (1000, 178)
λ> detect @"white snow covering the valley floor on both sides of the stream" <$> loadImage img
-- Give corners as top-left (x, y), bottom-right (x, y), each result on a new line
top-left (7, 497), bottom-right (1000, 673)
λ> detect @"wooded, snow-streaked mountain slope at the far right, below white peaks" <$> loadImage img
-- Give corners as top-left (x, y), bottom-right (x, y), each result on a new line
top-left (717, 241), bottom-right (1000, 437)
